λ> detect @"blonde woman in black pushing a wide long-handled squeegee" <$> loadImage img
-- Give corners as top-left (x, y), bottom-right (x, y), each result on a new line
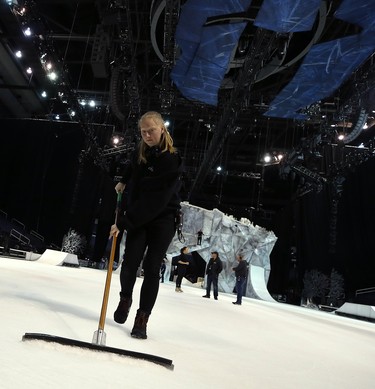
top-left (110, 111), bottom-right (182, 339)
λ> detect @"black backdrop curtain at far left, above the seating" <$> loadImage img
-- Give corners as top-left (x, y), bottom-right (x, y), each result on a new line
top-left (0, 119), bottom-right (98, 245)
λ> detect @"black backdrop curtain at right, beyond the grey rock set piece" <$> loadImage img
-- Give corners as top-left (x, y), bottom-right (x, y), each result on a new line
top-left (268, 159), bottom-right (375, 300)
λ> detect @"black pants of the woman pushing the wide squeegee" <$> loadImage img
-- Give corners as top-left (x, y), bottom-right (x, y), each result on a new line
top-left (120, 213), bottom-right (175, 314)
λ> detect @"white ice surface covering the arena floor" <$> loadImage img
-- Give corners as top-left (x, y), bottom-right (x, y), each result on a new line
top-left (0, 258), bottom-right (375, 389)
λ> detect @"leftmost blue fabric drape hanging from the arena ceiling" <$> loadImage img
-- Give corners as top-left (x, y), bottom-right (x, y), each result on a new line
top-left (171, 0), bottom-right (251, 105)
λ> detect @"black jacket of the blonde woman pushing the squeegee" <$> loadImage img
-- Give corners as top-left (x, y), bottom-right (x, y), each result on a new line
top-left (117, 147), bottom-right (182, 230)
